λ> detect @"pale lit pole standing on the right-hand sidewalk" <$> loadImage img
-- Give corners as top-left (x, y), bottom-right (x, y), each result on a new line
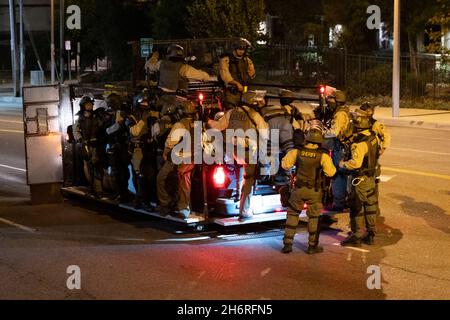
top-left (392, 0), bottom-right (400, 117)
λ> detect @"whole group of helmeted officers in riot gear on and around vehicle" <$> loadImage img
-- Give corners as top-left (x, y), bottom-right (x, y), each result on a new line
top-left (73, 38), bottom-right (390, 254)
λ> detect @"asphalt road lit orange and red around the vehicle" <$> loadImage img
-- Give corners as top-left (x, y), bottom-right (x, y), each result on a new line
top-left (0, 108), bottom-right (450, 299)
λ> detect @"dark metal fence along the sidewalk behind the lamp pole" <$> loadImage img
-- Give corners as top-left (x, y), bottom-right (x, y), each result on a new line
top-left (254, 44), bottom-right (450, 98)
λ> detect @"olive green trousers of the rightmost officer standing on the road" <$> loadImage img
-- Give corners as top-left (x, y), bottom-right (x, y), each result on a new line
top-left (350, 176), bottom-right (378, 238)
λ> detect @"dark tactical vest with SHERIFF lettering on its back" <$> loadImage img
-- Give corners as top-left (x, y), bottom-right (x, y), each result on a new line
top-left (295, 147), bottom-right (324, 191)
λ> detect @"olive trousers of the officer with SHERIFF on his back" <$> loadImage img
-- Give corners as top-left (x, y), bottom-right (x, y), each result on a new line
top-left (283, 187), bottom-right (322, 246)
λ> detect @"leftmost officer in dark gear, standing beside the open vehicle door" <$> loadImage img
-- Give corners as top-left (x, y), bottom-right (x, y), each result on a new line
top-left (73, 95), bottom-right (106, 198)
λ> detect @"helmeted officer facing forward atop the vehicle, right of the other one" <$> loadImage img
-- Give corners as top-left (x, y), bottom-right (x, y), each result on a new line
top-left (219, 38), bottom-right (256, 108)
